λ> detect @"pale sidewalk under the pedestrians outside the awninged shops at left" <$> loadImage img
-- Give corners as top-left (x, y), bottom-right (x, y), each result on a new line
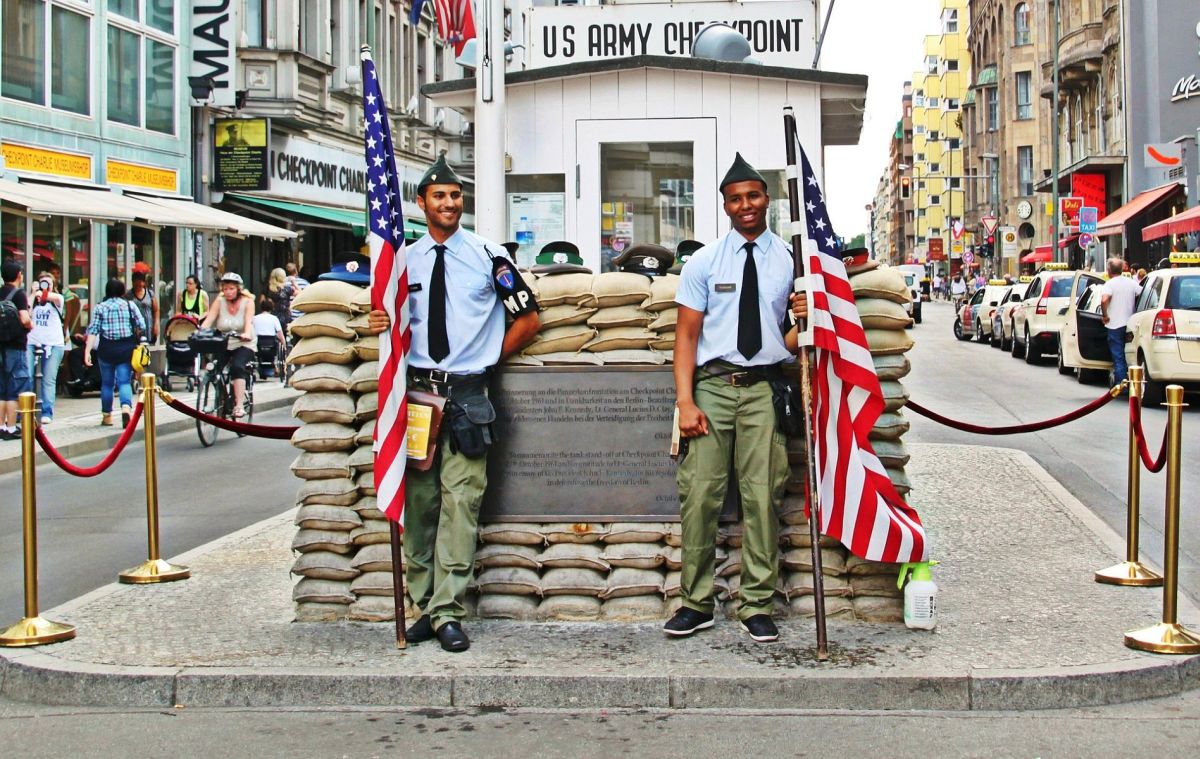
top-left (0, 377), bottom-right (300, 474)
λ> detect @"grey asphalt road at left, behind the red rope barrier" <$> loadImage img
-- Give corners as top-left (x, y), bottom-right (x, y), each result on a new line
top-left (0, 408), bottom-right (299, 627)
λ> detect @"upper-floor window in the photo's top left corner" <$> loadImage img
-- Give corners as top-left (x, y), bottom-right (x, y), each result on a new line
top-left (0, 0), bottom-right (91, 114)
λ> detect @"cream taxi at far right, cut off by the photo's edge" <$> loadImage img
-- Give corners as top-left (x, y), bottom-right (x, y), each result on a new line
top-left (1126, 267), bottom-right (1200, 406)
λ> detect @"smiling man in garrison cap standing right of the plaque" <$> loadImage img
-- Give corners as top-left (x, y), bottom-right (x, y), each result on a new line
top-left (662, 154), bottom-right (808, 643)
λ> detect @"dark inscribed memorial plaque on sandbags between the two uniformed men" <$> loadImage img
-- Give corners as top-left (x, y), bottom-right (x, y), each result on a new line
top-left (481, 366), bottom-right (679, 521)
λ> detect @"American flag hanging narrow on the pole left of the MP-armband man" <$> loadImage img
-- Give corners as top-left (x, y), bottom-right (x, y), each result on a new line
top-left (362, 47), bottom-right (413, 522)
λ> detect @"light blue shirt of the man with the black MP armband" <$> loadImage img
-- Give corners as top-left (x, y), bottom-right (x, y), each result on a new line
top-left (408, 228), bottom-right (505, 375)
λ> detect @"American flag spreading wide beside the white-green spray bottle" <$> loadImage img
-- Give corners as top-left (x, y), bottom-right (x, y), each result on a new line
top-left (800, 141), bottom-right (928, 562)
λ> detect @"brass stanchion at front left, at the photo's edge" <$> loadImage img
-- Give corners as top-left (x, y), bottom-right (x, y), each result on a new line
top-left (0, 393), bottom-right (74, 647)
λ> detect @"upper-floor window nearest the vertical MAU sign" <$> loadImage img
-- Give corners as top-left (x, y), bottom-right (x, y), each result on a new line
top-left (106, 7), bottom-right (179, 135)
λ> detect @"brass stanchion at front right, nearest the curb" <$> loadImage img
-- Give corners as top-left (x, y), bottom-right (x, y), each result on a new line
top-left (1126, 384), bottom-right (1200, 653)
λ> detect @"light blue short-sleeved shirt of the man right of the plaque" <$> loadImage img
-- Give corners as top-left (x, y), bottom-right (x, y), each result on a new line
top-left (676, 229), bottom-right (794, 366)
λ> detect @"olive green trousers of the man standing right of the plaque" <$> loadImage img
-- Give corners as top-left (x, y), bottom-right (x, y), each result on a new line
top-left (676, 378), bottom-right (788, 620)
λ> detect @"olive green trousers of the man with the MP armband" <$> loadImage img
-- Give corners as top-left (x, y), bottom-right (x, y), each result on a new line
top-left (404, 428), bottom-right (487, 629)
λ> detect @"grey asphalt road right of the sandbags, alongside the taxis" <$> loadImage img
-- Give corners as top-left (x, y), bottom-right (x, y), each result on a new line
top-left (904, 303), bottom-right (1200, 600)
